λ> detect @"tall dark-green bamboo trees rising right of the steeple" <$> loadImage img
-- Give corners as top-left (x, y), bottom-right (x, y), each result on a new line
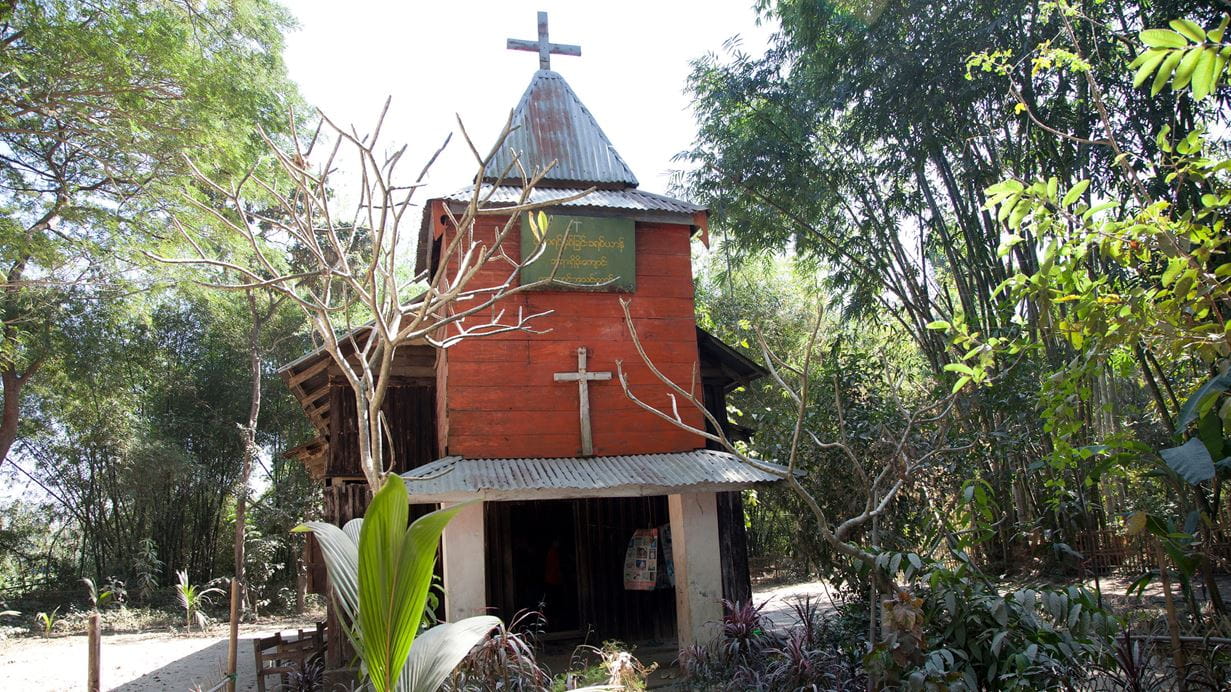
top-left (681, 0), bottom-right (1213, 564)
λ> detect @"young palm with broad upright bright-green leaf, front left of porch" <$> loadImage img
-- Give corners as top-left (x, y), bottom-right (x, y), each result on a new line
top-left (295, 475), bottom-right (500, 692)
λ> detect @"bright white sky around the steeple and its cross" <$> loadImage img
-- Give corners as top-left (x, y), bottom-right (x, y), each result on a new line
top-left (287, 0), bottom-right (771, 199)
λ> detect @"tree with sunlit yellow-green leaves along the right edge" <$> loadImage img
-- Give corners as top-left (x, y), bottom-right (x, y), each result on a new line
top-left (953, 2), bottom-right (1231, 614)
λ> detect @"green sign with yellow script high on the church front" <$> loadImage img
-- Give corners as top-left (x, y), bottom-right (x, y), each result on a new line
top-left (522, 214), bottom-right (636, 293)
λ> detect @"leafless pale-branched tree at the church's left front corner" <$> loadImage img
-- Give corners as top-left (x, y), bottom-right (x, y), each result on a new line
top-left (156, 101), bottom-right (588, 490)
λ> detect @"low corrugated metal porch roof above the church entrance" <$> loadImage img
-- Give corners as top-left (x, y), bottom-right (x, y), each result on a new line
top-left (403, 449), bottom-right (787, 502)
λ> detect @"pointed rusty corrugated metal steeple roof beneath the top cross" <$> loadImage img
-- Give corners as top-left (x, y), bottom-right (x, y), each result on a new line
top-left (489, 70), bottom-right (638, 187)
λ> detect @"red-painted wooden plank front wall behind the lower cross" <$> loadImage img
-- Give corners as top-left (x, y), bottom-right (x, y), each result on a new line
top-left (437, 211), bottom-right (704, 458)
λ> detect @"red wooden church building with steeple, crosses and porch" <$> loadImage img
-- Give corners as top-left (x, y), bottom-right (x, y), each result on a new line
top-left (281, 14), bottom-right (777, 648)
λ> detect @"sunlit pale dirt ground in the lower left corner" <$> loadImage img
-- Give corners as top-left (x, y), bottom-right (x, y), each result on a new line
top-left (0, 622), bottom-right (322, 692)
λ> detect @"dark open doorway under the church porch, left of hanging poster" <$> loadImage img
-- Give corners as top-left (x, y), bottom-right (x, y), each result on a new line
top-left (486, 500), bottom-right (581, 633)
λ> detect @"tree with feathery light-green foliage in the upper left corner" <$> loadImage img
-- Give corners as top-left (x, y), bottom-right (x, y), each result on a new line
top-left (0, 0), bottom-right (298, 462)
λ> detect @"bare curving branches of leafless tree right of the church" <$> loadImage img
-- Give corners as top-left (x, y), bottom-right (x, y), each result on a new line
top-left (616, 299), bottom-right (969, 593)
